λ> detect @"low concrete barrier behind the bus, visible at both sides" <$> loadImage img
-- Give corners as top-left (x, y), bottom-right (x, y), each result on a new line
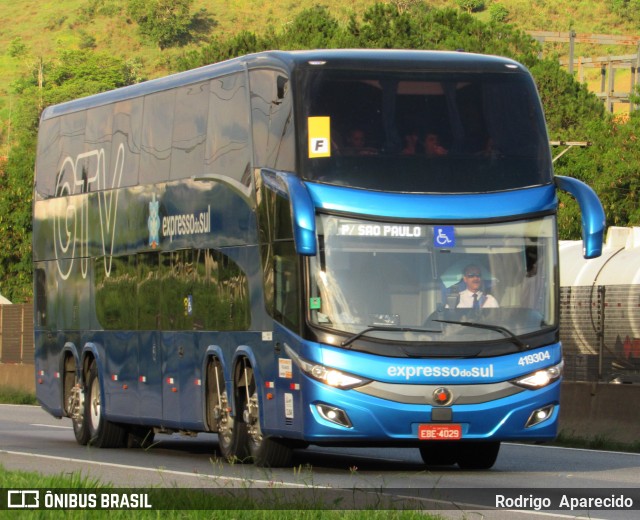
top-left (0, 363), bottom-right (640, 443)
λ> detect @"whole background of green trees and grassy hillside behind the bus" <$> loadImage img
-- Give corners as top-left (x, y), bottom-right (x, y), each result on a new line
top-left (0, 0), bottom-right (640, 303)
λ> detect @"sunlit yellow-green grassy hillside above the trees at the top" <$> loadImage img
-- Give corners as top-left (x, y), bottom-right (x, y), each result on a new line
top-left (0, 0), bottom-right (640, 146)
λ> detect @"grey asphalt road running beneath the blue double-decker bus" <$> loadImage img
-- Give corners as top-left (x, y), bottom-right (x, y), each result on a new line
top-left (0, 405), bottom-right (640, 520)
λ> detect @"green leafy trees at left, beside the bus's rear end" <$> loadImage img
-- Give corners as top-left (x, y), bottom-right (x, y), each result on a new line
top-left (0, 51), bottom-right (135, 302)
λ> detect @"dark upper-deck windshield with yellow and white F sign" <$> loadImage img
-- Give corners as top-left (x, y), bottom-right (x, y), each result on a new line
top-left (300, 65), bottom-right (552, 193)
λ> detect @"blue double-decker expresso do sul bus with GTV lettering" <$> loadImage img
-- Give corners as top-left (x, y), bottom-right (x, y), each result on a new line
top-left (33, 50), bottom-right (604, 469)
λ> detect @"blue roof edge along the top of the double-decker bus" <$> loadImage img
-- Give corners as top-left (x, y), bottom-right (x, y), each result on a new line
top-left (41, 49), bottom-right (525, 120)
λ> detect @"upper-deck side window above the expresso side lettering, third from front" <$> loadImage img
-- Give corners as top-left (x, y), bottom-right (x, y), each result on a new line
top-left (171, 83), bottom-right (209, 179)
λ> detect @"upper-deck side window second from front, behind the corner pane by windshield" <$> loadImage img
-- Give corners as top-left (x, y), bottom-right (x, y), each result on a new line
top-left (205, 73), bottom-right (251, 186)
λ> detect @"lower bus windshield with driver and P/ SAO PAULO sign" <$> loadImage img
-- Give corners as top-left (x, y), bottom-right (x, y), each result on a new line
top-left (309, 211), bottom-right (557, 350)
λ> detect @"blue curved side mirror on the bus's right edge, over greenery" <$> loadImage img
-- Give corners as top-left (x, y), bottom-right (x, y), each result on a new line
top-left (554, 175), bottom-right (605, 258)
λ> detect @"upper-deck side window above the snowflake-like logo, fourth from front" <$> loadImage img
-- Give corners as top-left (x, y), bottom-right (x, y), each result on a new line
top-left (140, 90), bottom-right (176, 184)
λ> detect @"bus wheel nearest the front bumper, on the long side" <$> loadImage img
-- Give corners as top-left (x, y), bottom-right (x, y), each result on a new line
top-left (243, 367), bottom-right (293, 468)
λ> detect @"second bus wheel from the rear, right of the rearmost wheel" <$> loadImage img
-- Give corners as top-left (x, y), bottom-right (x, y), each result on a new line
top-left (84, 363), bottom-right (125, 448)
